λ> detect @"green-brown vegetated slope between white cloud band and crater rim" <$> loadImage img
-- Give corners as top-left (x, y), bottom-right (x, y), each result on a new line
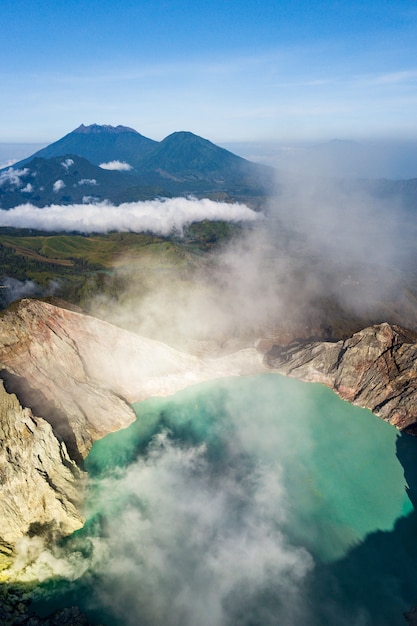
top-left (0, 222), bottom-right (228, 309)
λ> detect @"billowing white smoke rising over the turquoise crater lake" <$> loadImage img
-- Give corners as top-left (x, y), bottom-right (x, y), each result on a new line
top-left (13, 414), bottom-right (314, 626)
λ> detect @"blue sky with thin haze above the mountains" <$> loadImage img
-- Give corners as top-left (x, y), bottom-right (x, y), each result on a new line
top-left (0, 0), bottom-right (417, 143)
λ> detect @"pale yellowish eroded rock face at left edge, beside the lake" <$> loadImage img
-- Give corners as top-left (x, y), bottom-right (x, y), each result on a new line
top-left (0, 381), bottom-right (84, 553)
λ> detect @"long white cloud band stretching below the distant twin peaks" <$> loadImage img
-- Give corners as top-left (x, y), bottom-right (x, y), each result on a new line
top-left (0, 198), bottom-right (261, 235)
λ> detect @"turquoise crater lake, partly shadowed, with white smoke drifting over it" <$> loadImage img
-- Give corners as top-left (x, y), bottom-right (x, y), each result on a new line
top-left (20, 375), bottom-right (417, 626)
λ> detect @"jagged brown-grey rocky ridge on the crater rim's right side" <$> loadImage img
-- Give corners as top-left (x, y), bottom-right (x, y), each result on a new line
top-left (265, 323), bottom-right (417, 432)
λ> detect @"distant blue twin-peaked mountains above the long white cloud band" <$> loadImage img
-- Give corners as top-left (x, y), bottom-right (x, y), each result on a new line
top-left (0, 124), bottom-right (274, 209)
